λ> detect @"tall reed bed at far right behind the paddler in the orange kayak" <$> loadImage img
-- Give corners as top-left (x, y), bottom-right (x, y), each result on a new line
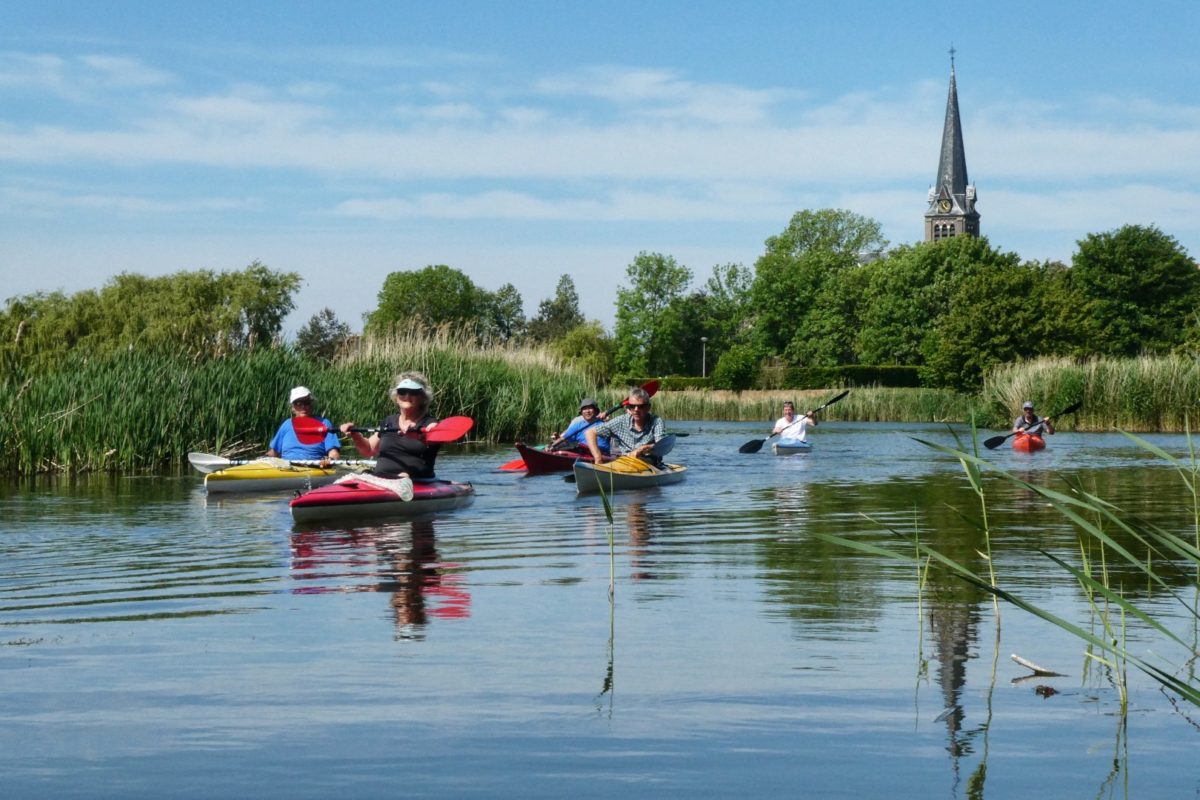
top-left (982, 355), bottom-right (1200, 432)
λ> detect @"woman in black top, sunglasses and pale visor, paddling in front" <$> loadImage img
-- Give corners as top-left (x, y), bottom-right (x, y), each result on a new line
top-left (341, 372), bottom-right (440, 479)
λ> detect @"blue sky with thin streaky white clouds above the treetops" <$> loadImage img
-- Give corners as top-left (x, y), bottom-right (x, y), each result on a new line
top-left (0, 0), bottom-right (1200, 330)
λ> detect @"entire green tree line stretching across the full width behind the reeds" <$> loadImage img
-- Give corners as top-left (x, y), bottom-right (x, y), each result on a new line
top-left (0, 209), bottom-right (1200, 391)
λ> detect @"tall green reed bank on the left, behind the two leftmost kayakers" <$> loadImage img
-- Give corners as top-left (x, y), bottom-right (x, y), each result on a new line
top-left (0, 336), bottom-right (592, 474)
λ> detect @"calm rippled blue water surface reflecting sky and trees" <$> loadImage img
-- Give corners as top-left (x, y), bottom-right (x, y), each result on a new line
top-left (0, 423), bottom-right (1200, 799)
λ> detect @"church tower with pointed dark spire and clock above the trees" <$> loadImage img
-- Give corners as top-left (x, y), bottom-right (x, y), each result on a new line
top-left (925, 52), bottom-right (979, 241)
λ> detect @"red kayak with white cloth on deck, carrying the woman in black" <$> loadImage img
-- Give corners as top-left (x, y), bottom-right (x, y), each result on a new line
top-left (289, 475), bottom-right (475, 522)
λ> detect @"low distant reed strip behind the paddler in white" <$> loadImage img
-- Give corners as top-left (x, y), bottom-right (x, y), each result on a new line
top-left (654, 387), bottom-right (985, 422)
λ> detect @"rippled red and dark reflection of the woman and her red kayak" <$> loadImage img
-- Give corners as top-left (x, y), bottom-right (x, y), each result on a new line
top-left (290, 519), bottom-right (470, 639)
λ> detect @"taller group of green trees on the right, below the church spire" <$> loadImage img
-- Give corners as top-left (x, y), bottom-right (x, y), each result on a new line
top-left (614, 209), bottom-right (1200, 391)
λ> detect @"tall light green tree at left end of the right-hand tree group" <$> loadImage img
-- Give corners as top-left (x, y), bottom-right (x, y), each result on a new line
top-left (616, 252), bottom-right (691, 377)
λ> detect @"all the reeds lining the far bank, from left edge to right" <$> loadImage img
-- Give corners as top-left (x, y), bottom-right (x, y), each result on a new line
top-left (9, 345), bottom-right (1200, 474)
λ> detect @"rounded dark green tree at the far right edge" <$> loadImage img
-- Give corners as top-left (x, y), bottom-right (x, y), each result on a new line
top-left (1072, 225), bottom-right (1200, 356)
